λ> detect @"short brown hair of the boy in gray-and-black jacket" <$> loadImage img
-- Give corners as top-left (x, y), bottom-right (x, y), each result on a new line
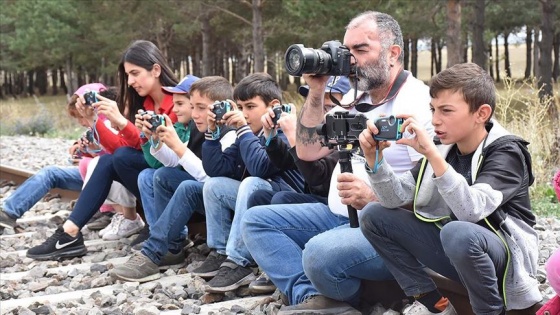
top-left (430, 63), bottom-right (496, 117)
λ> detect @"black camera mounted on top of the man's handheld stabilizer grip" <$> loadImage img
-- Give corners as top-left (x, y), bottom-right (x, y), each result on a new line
top-left (316, 112), bottom-right (368, 148)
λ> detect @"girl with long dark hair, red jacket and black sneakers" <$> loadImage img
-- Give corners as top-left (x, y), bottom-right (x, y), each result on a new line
top-left (27, 41), bottom-right (178, 260)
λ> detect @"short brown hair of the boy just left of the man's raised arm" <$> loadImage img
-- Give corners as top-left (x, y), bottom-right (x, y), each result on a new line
top-left (233, 72), bottom-right (282, 105)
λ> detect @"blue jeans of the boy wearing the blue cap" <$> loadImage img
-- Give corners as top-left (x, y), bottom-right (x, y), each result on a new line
top-left (138, 167), bottom-right (194, 227)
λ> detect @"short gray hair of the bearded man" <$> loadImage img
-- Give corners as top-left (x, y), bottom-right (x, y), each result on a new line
top-left (346, 11), bottom-right (404, 63)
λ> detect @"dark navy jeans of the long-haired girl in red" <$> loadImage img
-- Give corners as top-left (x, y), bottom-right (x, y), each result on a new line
top-left (68, 147), bottom-right (149, 229)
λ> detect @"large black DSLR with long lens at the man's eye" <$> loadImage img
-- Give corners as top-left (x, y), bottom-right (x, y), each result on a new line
top-left (285, 40), bottom-right (353, 77)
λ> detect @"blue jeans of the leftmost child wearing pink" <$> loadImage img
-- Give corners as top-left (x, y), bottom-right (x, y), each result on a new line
top-left (2, 166), bottom-right (84, 219)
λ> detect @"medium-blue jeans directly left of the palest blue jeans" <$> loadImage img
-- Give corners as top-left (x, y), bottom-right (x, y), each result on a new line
top-left (142, 179), bottom-right (204, 264)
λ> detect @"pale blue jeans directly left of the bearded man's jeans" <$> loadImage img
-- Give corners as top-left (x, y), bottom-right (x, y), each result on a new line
top-left (203, 177), bottom-right (272, 267)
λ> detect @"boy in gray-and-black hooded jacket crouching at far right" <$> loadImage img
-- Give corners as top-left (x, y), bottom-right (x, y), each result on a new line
top-left (360, 63), bottom-right (541, 314)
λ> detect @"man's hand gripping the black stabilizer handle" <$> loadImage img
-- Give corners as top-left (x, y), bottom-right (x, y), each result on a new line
top-left (336, 173), bottom-right (377, 210)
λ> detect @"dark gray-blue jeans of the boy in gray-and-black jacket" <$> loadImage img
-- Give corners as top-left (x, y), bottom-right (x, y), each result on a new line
top-left (360, 203), bottom-right (507, 314)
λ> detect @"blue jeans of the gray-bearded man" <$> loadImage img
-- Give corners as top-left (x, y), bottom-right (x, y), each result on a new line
top-left (242, 203), bottom-right (392, 305)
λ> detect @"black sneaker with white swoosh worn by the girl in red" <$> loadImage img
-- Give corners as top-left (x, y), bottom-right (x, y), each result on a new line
top-left (26, 227), bottom-right (87, 260)
